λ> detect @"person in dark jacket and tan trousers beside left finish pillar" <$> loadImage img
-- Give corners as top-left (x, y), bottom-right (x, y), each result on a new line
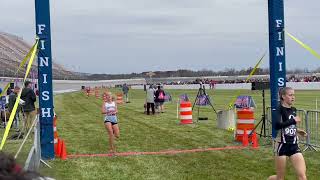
top-left (21, 81), bottom-right (37, 133)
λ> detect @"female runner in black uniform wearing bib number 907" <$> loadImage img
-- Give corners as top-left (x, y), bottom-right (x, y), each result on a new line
top-left (269, 87), bottom-right (307, 180)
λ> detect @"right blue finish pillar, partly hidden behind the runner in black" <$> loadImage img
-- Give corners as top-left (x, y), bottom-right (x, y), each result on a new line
top-left (268, 0), bottom-right (286, 138)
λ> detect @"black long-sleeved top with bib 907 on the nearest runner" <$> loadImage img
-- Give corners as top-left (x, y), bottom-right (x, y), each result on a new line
top-left (275, 105), bottom-right (298, 144)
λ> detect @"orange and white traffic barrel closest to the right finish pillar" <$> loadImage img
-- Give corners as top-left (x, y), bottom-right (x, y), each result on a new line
top-left (235, 108), bottom-right (255, 141)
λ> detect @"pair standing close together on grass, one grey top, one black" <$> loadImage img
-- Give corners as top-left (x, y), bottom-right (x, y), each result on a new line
top-left (145, 85), bottom-right (166, 115)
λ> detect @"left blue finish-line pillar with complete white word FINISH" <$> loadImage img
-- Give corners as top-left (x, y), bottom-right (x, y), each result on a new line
top-left (35, 0), bottom-right (54, 159)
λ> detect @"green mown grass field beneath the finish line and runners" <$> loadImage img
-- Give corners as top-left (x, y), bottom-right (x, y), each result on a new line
top-left (1, 89), bottom-right (320, 179)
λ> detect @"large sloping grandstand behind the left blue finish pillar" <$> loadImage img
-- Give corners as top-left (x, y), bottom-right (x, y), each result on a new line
top-left (0, 32), bottom-right (85, 80)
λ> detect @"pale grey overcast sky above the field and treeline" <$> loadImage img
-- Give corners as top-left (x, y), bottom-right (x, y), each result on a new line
top-left (0, 0), bottom-right (320, 74)
